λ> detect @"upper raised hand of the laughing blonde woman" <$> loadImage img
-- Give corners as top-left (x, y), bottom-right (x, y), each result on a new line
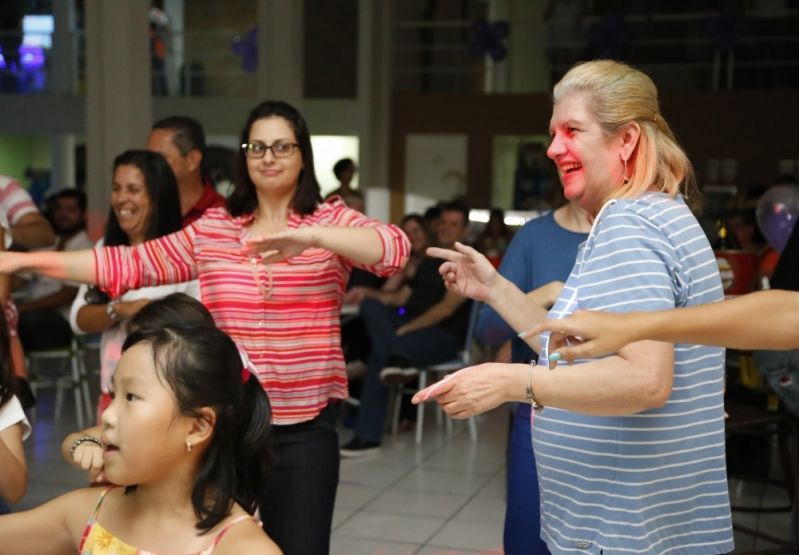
top-left (427, 243), bottom-right (499, 301)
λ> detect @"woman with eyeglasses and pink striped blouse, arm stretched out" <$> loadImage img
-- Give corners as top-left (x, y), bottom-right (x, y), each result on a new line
top-left (0, 101), bottom-right (410, 555)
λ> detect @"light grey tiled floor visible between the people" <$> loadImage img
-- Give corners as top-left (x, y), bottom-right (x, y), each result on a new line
top-left (9, 386), bottom-right (790, 555)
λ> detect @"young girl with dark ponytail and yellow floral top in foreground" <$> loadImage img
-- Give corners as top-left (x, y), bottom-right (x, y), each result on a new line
top-left (0, 314), bottom-right (280, 555)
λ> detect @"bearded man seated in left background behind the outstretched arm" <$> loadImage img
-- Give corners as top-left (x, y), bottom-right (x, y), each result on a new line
top-left (17, 189), bottom-right (92, 350)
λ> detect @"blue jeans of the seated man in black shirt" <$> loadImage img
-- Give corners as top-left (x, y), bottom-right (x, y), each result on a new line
top-left (355, 299), bottom-right (463, 443)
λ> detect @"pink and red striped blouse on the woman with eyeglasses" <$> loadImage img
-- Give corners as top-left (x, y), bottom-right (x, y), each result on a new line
top-left (95, 198), bottom-right (410, 424)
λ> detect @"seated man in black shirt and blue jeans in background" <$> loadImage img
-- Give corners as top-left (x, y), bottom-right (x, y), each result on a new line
top-left (341, 203), bottom-right (469, 457)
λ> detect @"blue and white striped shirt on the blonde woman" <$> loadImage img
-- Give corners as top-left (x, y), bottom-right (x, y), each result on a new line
top-left (533, 193), bottom-right (733, 555)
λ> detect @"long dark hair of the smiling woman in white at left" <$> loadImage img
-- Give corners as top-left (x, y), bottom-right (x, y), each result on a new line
top-left (104, 150), bottom-right (182, 247)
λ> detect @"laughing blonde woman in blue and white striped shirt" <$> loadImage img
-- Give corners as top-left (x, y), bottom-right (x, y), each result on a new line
top-left (414, 60), bottom-right (733, 555)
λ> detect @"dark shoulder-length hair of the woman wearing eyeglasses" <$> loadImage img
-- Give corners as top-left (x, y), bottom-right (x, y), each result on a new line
top-left (227, 100), bottom-right (322, 216)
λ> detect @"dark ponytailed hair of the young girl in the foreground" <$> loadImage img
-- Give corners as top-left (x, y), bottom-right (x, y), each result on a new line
top-left (122, 322), bottom-right (271, 532)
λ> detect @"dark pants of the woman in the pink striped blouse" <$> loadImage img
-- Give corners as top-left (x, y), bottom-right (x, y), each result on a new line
top-left (260, 405), bottom-right (339, 555)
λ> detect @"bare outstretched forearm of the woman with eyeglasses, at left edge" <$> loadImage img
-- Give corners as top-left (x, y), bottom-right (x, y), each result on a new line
top-left (0, 250), bottom-right (96, 283)
